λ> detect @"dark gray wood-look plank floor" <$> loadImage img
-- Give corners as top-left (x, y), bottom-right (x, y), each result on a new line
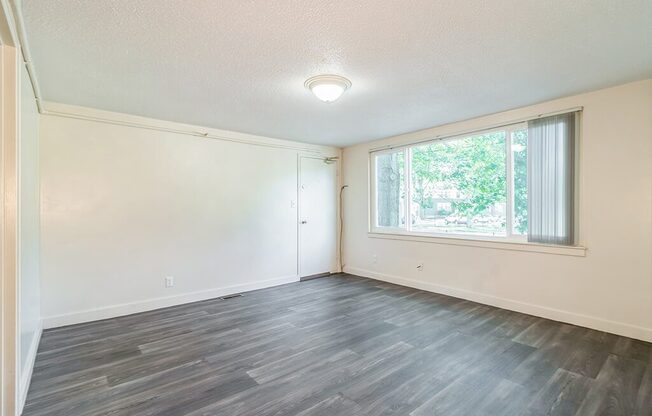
top-left (24, 275), bottom-right (652, 416)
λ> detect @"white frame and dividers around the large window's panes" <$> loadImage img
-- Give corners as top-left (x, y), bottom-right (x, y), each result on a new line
top-left (367, 115), bottom-right (587, 257)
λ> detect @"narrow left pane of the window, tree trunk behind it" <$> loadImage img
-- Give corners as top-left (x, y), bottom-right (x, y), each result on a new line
top-left (375, 150), bottom-right (405, 228)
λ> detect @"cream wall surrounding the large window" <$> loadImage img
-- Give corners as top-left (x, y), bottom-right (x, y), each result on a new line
top-left (343, 80), bottom-right (652, 341)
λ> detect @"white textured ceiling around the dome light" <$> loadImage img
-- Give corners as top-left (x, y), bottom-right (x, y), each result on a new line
top-left (23, 0), bottom-right (652, 146)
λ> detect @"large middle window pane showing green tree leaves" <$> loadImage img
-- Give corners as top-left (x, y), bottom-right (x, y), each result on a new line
top-left (410, 131), bottom-right (507, 236)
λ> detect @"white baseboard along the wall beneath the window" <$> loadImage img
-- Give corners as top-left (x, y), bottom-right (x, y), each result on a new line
top-left (344, 267), bottom-right (652, 342)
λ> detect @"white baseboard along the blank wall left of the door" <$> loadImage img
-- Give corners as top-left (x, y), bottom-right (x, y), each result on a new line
top-left (43, 275), bottom-right (299, 329)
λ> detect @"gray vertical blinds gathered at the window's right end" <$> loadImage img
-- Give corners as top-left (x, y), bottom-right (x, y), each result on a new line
top-left (527, 113), bottom-right (576, 245)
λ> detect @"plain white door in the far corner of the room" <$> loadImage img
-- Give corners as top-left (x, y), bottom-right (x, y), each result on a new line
top-left (299, 157), bottom-right (337, 277)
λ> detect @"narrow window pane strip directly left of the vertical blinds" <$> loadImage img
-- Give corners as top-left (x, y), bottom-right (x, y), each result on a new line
top-left (512, 129), bottom-right (527, 235)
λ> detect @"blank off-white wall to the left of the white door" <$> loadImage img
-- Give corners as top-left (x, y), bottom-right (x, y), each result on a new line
top-left (40, 110), bottom-right (337, 327)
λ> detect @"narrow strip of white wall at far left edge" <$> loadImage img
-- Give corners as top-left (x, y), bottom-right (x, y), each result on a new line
top-left (18, 64), bottom-right (41, 403)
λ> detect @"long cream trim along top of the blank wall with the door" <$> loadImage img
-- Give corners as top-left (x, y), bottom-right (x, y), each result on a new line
top-left (40, 101), bottom-right (339, 157)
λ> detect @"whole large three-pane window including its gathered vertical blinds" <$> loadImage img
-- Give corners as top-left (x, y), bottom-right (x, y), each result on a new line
top-left (371, 113), bottom-right (575, 245)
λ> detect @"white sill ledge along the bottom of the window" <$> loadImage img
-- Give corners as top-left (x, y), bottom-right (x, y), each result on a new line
top-left (367, 231), bottom-right (586, 257)
